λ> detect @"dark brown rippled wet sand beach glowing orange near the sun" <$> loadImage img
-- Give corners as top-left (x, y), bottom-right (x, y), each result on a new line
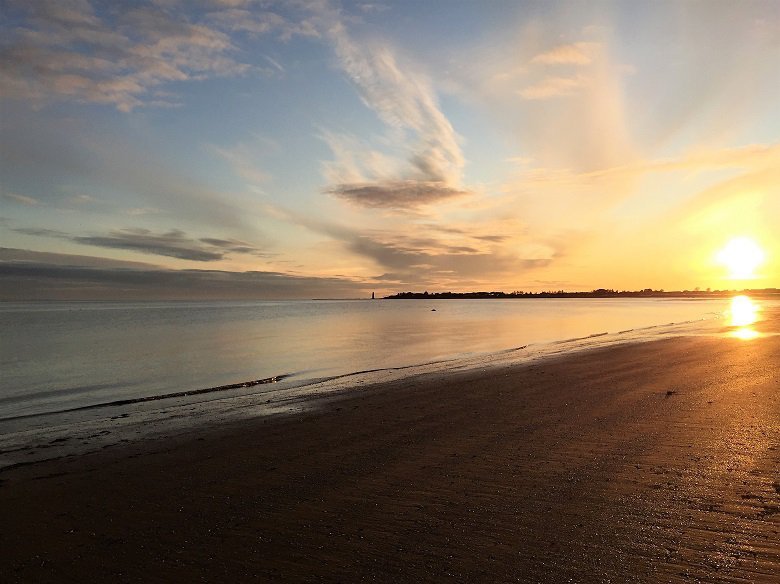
top-left (0, 317), bottom-right (780, 583)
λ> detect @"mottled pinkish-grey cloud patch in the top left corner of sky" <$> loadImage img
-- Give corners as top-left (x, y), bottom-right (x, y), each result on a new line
top-left (0, 0), bottom-right (251, 112)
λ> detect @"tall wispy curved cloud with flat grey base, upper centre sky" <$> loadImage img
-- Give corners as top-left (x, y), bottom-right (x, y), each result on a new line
top-left (320, 9), bottom-right (466, 209)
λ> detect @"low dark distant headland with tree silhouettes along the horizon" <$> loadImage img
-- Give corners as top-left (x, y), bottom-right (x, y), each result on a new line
top-left (384, 288), bottom-right (780, 300)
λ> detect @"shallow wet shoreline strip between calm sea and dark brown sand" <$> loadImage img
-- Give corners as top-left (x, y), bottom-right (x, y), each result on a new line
top-left (0, 317), bottom-right (723, 472)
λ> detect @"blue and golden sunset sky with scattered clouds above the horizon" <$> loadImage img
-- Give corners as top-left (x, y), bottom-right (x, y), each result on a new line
top-left (0, 0), bottom-right (780, 300)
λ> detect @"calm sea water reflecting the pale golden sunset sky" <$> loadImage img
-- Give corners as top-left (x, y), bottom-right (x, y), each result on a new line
top-left (0, 299), bottom-right (727, 420)
